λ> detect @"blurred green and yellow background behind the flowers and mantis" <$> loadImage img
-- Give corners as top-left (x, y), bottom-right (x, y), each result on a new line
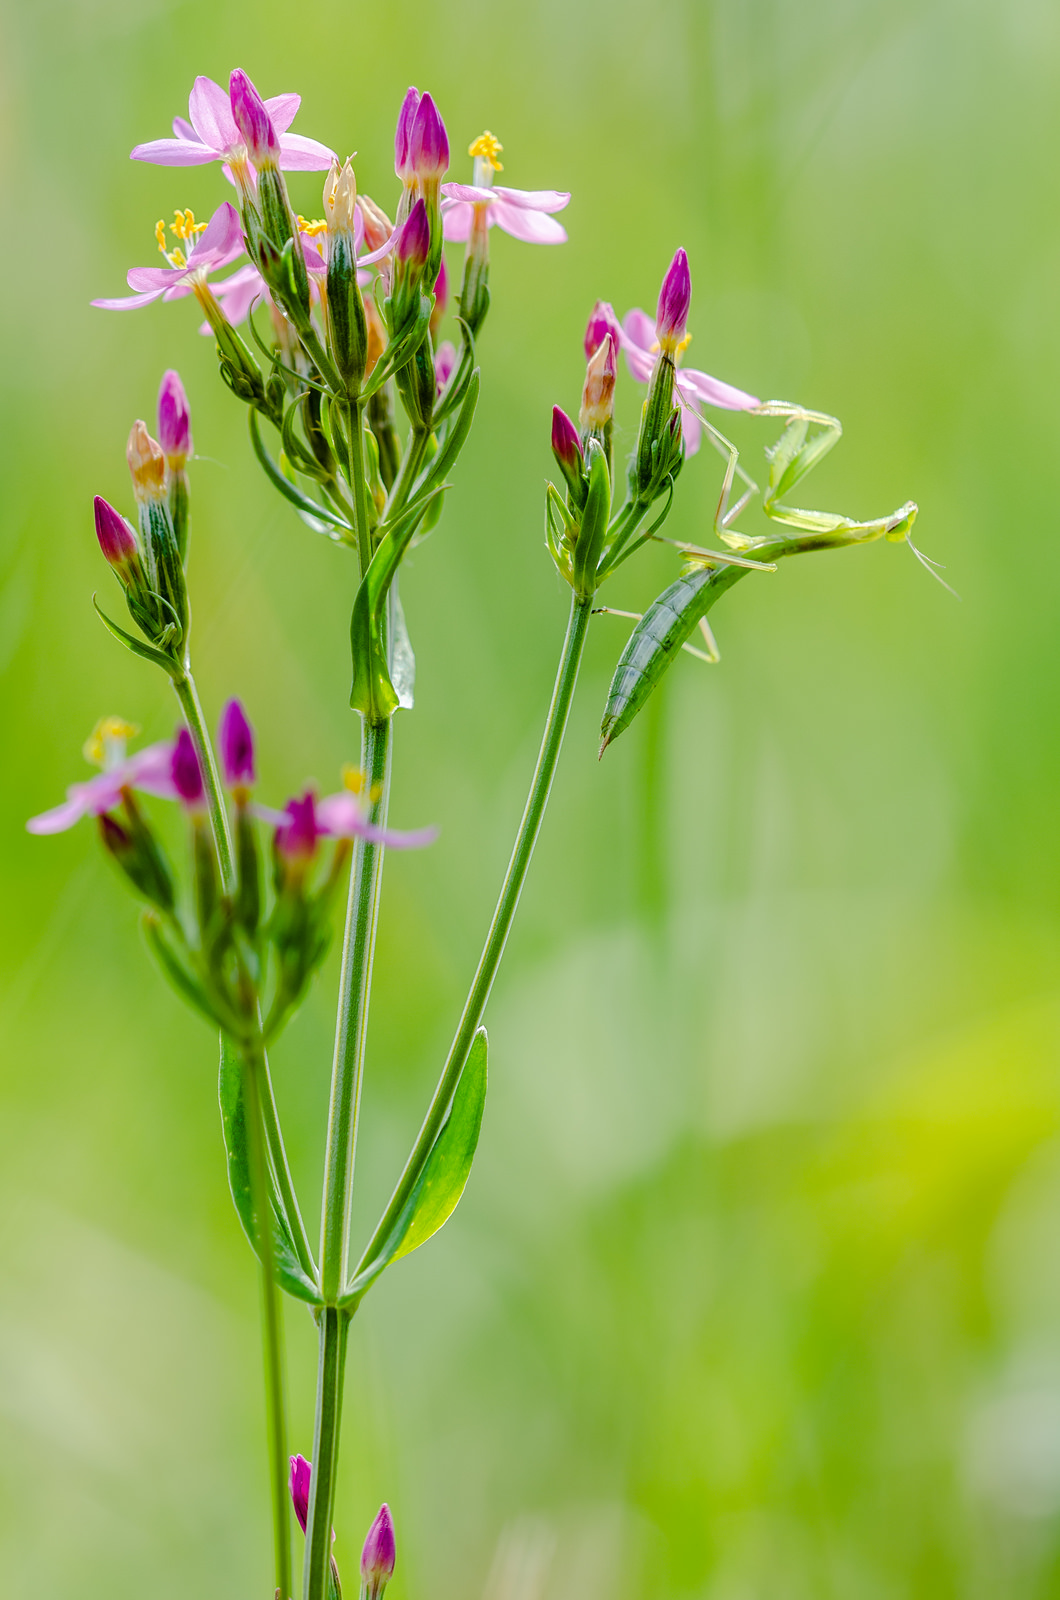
top-left (0, 0), bottom-right (1060, 1600)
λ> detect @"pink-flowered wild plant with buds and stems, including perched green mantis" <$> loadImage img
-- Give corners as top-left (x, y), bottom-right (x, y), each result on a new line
top-left (29, 70), bottom-right (916, 1600)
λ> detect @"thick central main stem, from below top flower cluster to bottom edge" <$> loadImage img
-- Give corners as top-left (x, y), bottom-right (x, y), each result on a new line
top-left (304, 718), bottom-right (391, 1600)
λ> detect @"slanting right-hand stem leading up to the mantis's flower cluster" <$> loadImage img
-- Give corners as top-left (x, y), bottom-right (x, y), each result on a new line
top-left (352, 594), bottom-right (592, 1280)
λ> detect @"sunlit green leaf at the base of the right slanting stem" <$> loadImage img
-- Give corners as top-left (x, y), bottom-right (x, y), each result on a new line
top-left (343, 1027), bottom-right (487, 1304)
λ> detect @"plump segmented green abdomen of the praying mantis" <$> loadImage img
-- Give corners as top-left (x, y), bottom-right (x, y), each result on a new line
top-left (600, 566), bottom-right (749, 755)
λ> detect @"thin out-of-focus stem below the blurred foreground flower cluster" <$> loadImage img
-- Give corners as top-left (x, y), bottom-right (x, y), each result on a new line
top-left (242, 1043), bottom-right (291, 1600)
